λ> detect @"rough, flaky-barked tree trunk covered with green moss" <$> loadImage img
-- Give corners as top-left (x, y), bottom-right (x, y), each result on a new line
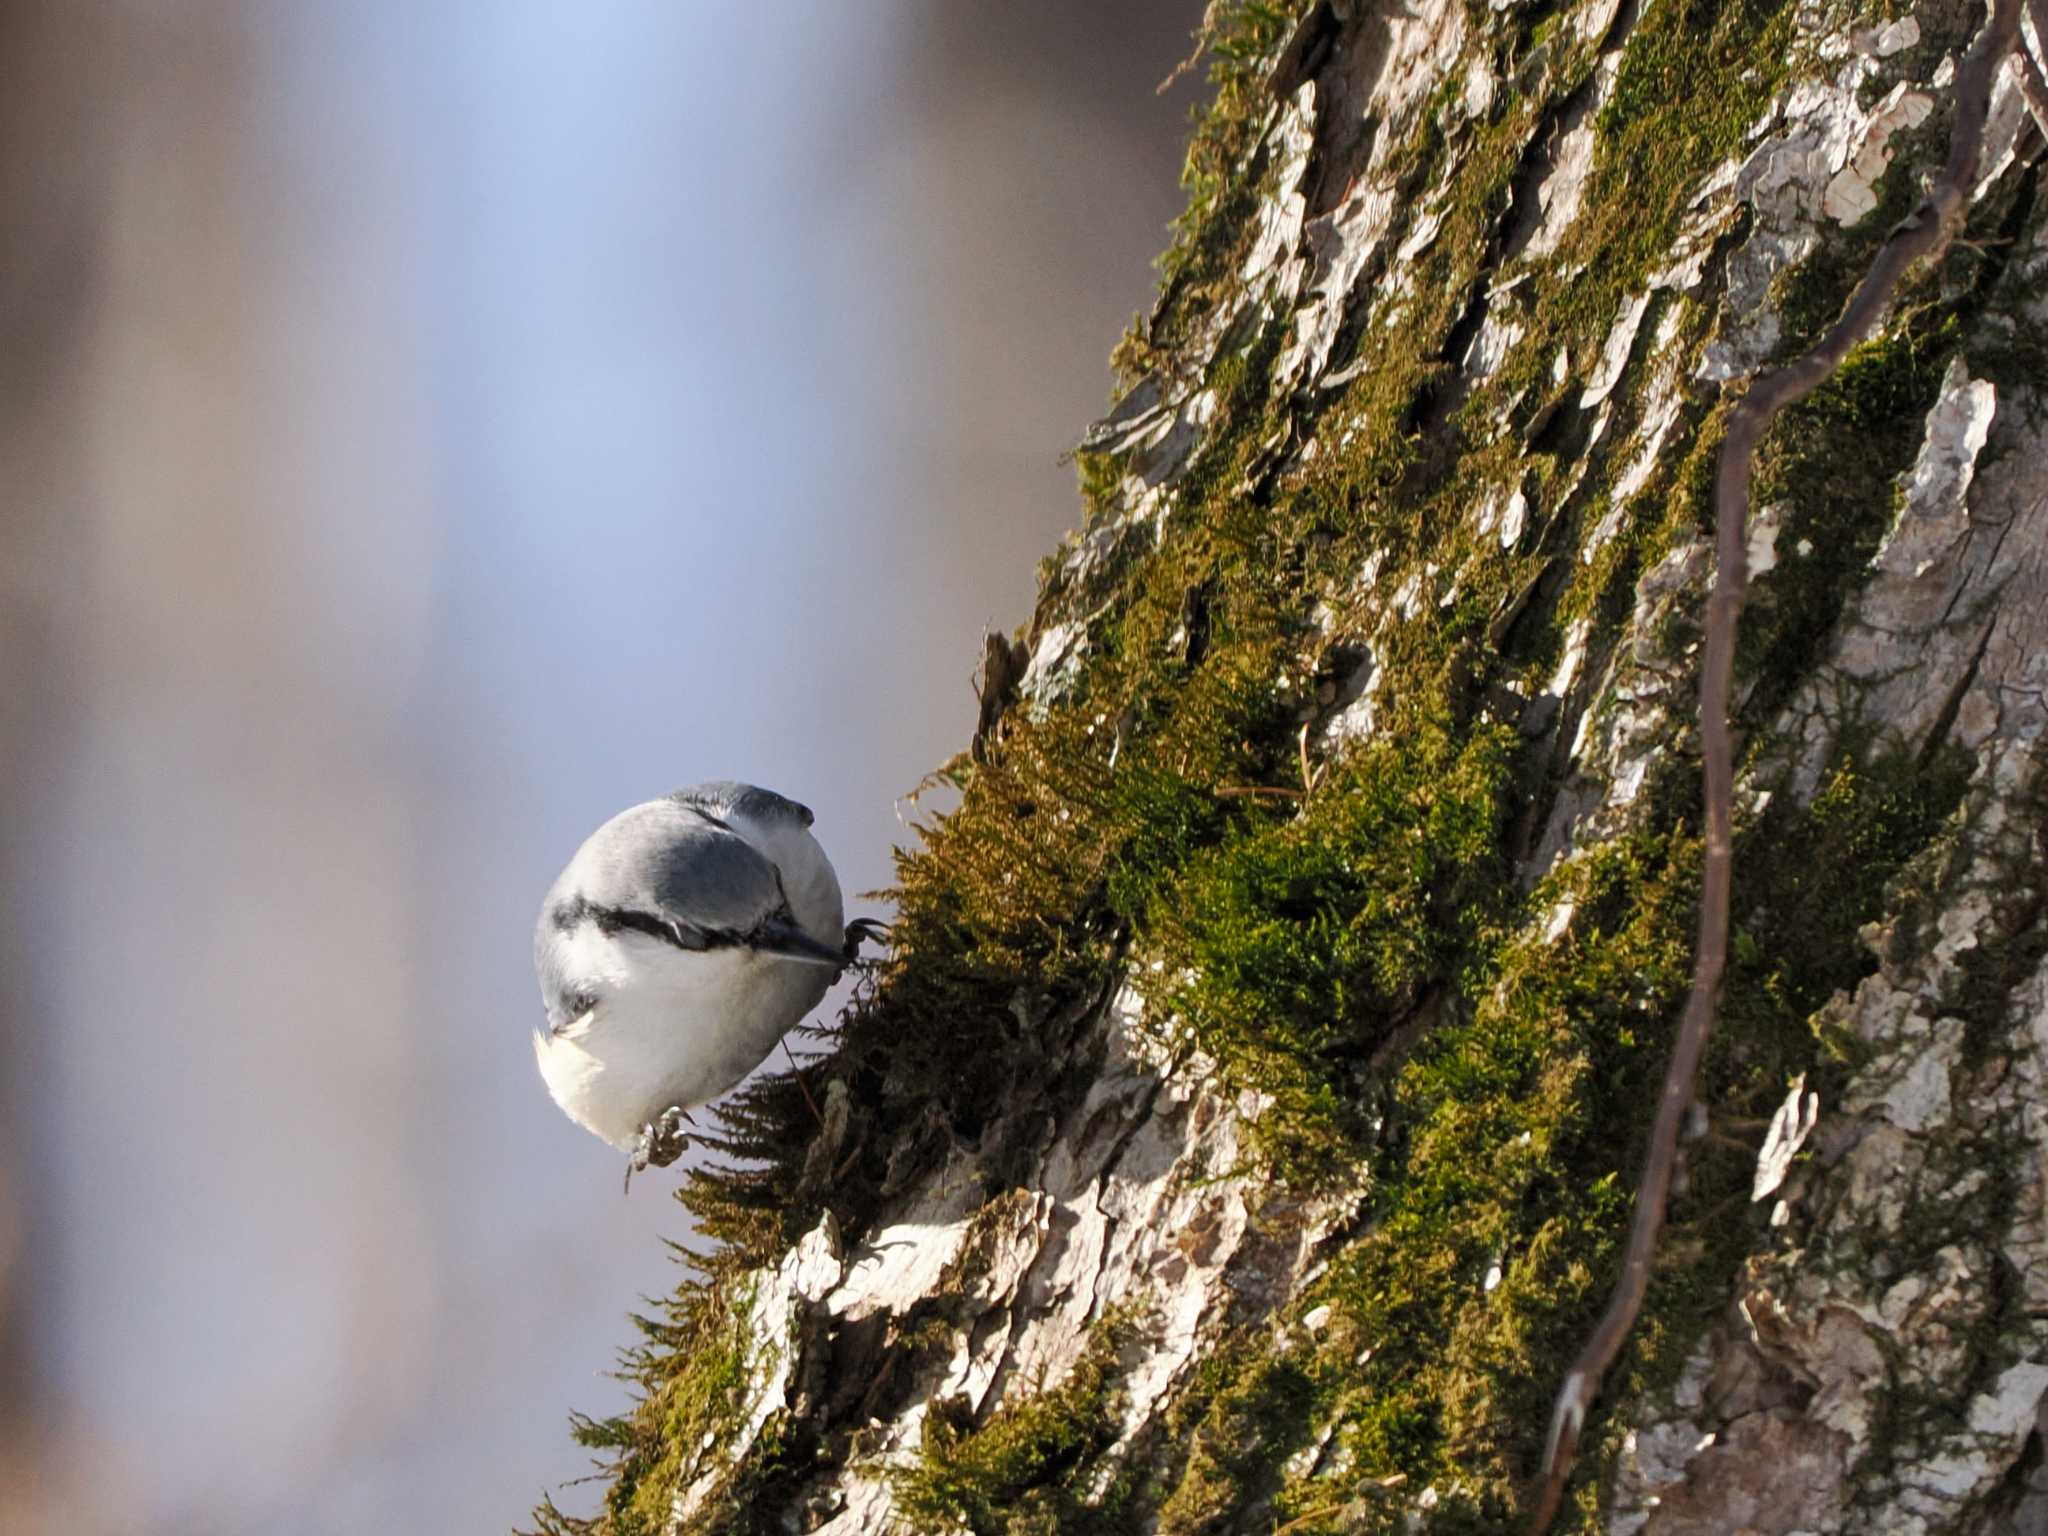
top-left (539, 0), bottom-right (2048, 1536)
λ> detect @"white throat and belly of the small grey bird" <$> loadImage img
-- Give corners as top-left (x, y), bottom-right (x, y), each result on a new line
top-left (532, 930), bottom-right (834, 1151)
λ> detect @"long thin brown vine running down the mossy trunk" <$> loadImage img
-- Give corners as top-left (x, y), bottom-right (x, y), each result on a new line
top-left (1528, 0), bottom-right (2015, 1536)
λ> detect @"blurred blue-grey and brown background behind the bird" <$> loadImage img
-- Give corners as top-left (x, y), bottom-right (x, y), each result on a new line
top-left (0, 0), bottom-right (1200, 1536)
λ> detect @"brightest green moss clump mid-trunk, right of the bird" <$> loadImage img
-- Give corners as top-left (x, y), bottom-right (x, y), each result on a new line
top-left (1137, 723), bottom-right (1513, 1182)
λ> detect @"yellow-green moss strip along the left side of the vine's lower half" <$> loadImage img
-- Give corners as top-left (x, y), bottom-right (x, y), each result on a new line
top-left (1286, 838), bottom-right (1692, 1530)
